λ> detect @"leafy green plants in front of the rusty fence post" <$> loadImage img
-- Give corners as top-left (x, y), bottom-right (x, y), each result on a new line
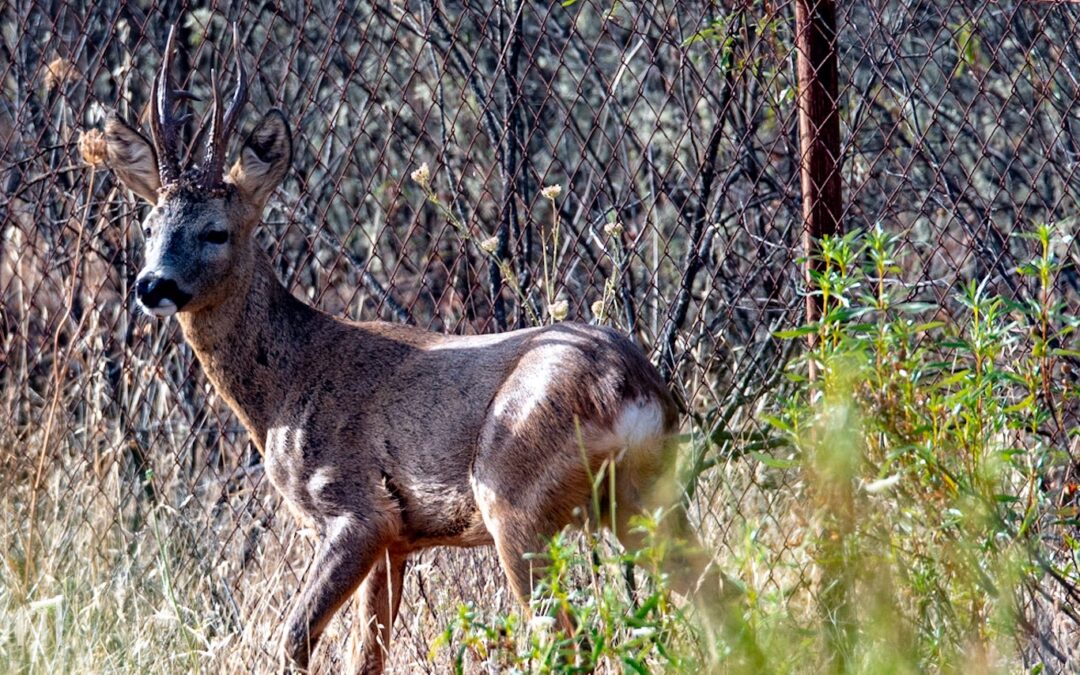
top-left (442, 227), bottom-right (1080, 673)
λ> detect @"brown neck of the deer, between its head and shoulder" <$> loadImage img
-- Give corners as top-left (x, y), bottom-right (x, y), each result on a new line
top-left (178, 249), bottom-right (322, 451)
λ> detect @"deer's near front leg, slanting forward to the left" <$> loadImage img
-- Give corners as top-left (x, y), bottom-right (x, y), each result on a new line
top-left (282, 515), bottom-right (384, 672)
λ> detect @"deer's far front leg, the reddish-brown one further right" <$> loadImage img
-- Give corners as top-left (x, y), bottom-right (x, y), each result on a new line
top-left (353, 551), bottom-right (406, 675)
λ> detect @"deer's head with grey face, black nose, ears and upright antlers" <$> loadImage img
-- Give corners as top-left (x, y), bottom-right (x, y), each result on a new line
top-left (105, 26), bottom-right (293, 316)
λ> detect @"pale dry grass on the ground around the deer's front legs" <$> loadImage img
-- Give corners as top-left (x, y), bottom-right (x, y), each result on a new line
top-left (0, 434), bottom-right (734, 673)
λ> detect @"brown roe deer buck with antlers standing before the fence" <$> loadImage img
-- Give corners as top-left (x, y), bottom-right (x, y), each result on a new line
top-left (104, 26), bottom-right (718, 673)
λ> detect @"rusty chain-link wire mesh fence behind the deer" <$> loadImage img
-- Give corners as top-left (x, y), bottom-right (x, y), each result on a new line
top-left (0, 0), bottom-right (1080, 672)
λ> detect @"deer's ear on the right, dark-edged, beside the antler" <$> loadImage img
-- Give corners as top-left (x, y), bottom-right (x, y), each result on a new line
top-left (229, 108), bottom-right (293, 212)
